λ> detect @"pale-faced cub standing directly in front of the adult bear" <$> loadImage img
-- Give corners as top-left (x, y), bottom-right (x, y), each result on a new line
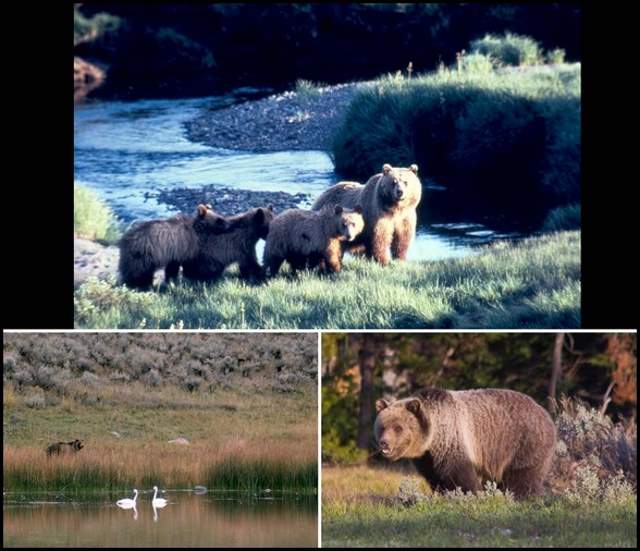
top-left (263, 205), bottom-right (364, 277)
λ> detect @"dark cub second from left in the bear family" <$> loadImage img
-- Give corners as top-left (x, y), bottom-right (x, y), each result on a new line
top-left (182, 205), bottom-right (275, 281)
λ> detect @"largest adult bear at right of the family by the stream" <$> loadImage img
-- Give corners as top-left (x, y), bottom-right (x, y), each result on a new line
top-left (313, 164), bottom-right (422, 265)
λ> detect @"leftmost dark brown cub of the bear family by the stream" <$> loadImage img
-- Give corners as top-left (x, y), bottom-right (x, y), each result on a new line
top-left (119, 205), bottom-right (235, 289)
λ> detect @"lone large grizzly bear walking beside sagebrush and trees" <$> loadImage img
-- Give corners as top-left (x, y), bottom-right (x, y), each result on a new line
top-left (374, 388), bottom-right (556, 497)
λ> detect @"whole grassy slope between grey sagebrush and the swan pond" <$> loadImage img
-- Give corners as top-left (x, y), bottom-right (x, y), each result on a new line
top-left (3, 383), bottom-right (317, 492)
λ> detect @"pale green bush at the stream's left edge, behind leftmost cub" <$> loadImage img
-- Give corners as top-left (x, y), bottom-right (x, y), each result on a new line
top-left (73, 184), bottom-right (121, 243)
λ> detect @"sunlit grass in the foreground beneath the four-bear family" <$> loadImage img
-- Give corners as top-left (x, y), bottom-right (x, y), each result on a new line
top-left (74, 232), bottom-right (580, 329)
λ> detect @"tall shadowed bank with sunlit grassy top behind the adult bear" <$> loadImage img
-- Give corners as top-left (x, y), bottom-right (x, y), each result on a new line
top-left (332, 62), bottom-right (581, 219)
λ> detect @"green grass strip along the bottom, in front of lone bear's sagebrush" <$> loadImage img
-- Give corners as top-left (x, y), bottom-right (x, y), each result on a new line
top-left (322, 498), bottom-right (637, 547)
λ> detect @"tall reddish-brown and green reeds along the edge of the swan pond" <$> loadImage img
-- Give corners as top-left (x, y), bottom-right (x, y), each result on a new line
top-left (3, 443), bottom-right (317, 492)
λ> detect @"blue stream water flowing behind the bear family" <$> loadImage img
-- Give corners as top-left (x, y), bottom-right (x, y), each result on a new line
top-left (74, 94), bottom-right (522, 260)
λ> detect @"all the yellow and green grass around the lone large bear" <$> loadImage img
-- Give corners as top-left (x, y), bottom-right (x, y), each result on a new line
top-left (322, 467), bottom-right (637, 547)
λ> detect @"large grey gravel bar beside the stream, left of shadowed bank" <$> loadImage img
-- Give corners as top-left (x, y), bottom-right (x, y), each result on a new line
top-left (185, 82), bottom-right (366, 152)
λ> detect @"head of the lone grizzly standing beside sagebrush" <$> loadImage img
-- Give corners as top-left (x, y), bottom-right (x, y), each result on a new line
top-left (373, 398), bottom-right (427, 461)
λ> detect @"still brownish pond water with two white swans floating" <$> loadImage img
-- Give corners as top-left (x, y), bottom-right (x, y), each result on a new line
top-left (2, 491), bottom-right (318, 548)
